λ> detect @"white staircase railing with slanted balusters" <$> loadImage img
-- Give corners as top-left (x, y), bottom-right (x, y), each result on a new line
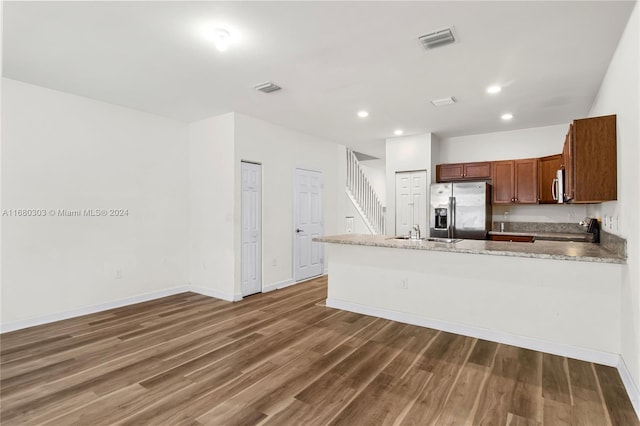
top-left (347, 149), bottom-right (385, 234)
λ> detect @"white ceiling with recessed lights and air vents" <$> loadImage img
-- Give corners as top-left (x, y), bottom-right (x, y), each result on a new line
top-left (3, 1), bottom-right (634, 157)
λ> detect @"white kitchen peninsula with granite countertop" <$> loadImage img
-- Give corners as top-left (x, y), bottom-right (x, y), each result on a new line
top-left (316, 234), bottom-right (625, 365)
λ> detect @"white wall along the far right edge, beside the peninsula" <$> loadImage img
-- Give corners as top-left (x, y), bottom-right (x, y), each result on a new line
top-left (589, 3), bottom-right (640, 402)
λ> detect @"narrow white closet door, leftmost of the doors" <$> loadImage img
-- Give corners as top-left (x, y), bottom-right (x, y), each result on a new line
top-left (240, 161), bottom-right (262, 296)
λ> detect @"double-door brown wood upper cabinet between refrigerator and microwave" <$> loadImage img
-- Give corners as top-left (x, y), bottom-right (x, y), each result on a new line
top-left (492, 158), bottom-right (538, 204)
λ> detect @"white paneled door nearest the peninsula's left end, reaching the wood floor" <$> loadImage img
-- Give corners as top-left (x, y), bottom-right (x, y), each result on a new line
top-left (293, 169), bottom-right (324, 281)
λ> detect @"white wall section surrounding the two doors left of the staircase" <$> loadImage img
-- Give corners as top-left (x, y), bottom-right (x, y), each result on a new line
top-left (234, 113), bottom-right (346, 292)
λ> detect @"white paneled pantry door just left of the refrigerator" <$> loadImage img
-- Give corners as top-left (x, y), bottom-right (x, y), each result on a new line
top-left (395, 170), bottom-right (429, 236)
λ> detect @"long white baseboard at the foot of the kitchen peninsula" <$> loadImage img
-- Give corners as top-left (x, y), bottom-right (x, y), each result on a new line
top-left (327, 298), bottom-right (620, 367)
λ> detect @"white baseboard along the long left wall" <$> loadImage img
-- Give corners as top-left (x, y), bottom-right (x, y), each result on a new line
top-left (0, 286), bottom-right (193, 333)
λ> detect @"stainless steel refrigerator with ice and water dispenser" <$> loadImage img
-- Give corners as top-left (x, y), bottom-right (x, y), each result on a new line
top-left (429, 182), bottom-right (491, 240)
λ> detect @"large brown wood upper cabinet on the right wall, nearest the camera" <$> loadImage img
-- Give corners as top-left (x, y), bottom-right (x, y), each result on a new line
top-left (563, 115), bottom-right (618, 203)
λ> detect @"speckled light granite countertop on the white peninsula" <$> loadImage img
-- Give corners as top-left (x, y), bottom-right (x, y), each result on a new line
top-left (314, 234), bottom-right (626, 264)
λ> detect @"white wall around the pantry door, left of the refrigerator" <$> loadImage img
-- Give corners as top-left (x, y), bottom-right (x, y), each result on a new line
top-left (385, 133), bottom-right (435, 235)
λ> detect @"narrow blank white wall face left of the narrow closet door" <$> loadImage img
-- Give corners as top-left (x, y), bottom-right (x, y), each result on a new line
top-left (189, 113), bottom-right (240, 300)
